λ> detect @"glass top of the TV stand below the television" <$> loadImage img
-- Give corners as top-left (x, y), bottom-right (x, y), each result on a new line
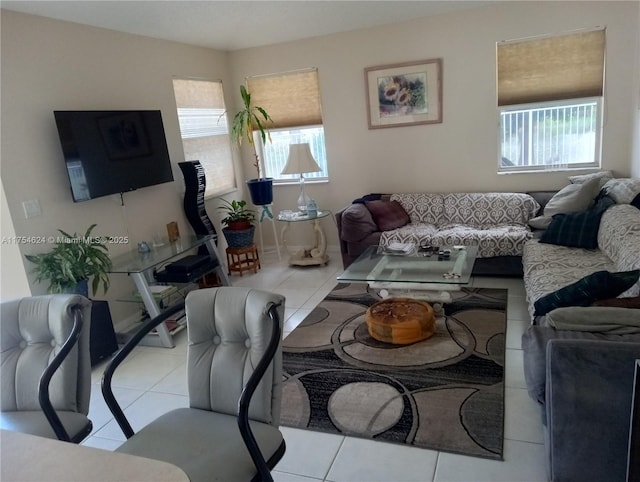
top-left (109, 234), bottom-right (215, 273)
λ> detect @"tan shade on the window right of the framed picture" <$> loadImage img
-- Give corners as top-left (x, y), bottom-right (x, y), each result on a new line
top-left (497, 29), bottom-right (605, 106)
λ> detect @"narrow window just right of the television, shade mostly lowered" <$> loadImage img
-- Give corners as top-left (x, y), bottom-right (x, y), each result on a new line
top-left (173, 79), bottom-right (237, 197)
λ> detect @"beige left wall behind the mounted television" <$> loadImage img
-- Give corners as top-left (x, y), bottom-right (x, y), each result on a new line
top-left (1, 10), bottom-right (236, 319)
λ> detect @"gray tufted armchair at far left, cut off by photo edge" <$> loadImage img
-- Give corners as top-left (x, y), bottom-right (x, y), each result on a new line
top-left (0, 295), bottom-right (92, 443)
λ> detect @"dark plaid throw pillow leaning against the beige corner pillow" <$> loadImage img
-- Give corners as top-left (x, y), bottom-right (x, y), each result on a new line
top-left (540, 196), bottom-right (615, 249)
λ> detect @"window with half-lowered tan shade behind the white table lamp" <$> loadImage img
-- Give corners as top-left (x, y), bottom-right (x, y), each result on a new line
top-left (247, 69), bottom-right (329, 184)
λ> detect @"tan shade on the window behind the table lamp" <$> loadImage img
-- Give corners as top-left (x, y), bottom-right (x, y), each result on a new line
top-left (247, 69), bottom-right (322, 128)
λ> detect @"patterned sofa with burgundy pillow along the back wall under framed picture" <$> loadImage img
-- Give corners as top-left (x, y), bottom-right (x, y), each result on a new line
top-left (336, 192), bottom-right (540, 274)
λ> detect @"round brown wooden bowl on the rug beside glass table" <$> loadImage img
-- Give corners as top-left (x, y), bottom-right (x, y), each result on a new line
top-left (365, 298), bottom-right (436, 345)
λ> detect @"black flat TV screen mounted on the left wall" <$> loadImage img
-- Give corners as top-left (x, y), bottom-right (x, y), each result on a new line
top-left (54, 110), bottom-right (173, 202)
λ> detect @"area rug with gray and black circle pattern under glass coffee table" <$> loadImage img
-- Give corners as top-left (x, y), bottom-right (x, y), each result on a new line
top-left (281, 283), bottom-right (507, 460)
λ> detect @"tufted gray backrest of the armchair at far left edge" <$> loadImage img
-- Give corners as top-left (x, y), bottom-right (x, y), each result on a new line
top-left (0, 295), bottom-right (91, 415)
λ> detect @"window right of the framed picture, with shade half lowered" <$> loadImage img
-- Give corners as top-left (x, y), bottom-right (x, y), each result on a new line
top-left (497, 29), bottom-right (605, 172)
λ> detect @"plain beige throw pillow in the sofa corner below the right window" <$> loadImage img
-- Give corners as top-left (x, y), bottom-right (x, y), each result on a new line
top-left (529, 177), bottom-right (600, 229)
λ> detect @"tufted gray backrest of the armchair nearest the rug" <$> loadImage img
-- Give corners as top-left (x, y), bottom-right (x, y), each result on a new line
top-left (185, 286), bottom-right (284, 426)
